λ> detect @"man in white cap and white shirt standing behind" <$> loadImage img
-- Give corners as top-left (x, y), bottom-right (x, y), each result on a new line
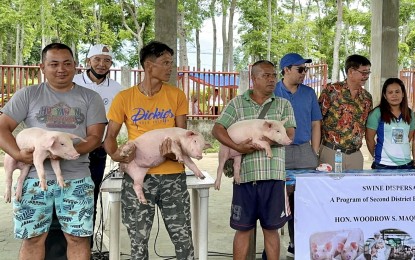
top-left (73, 44), bottom-right (122, 248)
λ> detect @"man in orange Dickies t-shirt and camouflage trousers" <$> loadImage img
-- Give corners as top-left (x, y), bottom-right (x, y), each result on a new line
top-left (104, 41), bottom-right (194, 260)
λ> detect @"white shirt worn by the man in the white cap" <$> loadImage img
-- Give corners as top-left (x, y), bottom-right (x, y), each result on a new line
top-left (72, 71), bottom-right (123, 113)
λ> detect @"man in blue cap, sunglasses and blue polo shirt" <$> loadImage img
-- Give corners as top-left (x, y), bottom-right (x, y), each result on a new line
top-left (266, 53), bottom-right (322, 257)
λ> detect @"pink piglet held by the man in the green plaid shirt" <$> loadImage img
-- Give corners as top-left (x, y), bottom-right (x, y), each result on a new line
top-left (215, 118), bottom-right (291, 190)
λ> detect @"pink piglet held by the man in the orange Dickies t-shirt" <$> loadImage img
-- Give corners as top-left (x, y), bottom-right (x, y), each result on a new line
top-left (120, 127), bottom-right (209, 204)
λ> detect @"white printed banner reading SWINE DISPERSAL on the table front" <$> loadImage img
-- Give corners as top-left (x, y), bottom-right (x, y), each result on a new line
top-left (294, 173), bottom-right (415, 260)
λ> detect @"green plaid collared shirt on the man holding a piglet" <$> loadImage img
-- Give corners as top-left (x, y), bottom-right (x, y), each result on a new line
top-left (216, 90), bottom-right (296, 183)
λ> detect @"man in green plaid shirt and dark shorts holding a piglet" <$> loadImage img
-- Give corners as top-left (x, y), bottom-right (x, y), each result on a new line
top-left (212, 60), bottom-right (296, 260)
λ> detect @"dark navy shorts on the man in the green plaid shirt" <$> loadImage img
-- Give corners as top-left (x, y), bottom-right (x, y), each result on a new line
top-left (230, 180), bottom-right (291, 231)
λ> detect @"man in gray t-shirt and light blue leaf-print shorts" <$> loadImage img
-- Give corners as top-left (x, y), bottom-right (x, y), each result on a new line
top-left (0, 43), bottom-right (107, 260)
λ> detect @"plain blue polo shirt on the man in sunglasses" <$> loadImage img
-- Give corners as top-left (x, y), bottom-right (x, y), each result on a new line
top-left (274, 80), bottom-right (322, 145)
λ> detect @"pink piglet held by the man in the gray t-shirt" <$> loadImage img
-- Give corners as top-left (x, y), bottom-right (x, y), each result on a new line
top-left (4, 127), bottom-right (86, 202)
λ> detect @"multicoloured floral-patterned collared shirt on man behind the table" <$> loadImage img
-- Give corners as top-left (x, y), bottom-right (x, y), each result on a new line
top-left (318, 81), bottom-right (372, 149)
